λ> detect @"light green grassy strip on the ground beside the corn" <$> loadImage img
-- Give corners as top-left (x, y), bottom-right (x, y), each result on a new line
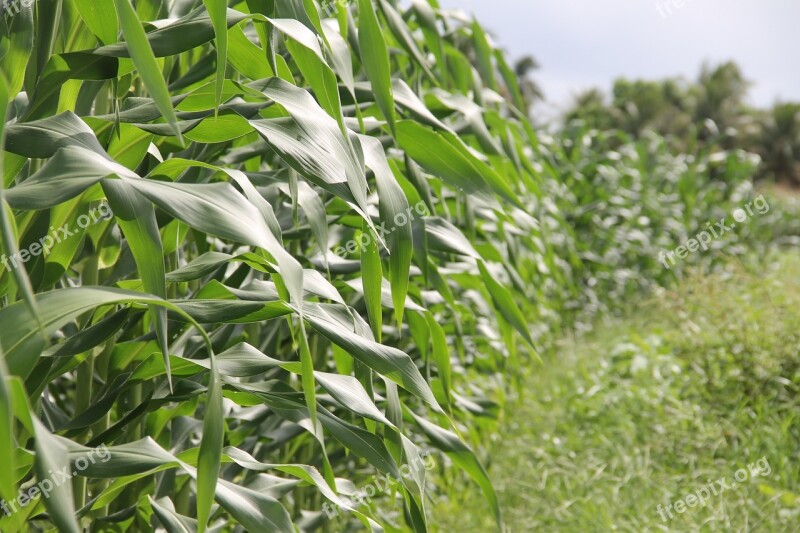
top-left (433, 254), bottom-right (800, 532)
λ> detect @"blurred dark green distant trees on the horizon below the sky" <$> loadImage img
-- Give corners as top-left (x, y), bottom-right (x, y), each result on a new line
top-left (564, 62), bottom-right (800, 186)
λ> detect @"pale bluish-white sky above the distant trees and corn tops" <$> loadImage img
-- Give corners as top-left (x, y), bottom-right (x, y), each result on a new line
top-left (439, 0), bottom-right (800, 116)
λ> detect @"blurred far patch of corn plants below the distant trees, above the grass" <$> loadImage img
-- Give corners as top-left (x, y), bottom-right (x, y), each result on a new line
top-left (541, 126), bottom-right (768, 322)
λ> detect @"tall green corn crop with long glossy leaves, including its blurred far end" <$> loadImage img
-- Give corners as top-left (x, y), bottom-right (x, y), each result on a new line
top-left (0, 0), bottom-right (764, 533)
